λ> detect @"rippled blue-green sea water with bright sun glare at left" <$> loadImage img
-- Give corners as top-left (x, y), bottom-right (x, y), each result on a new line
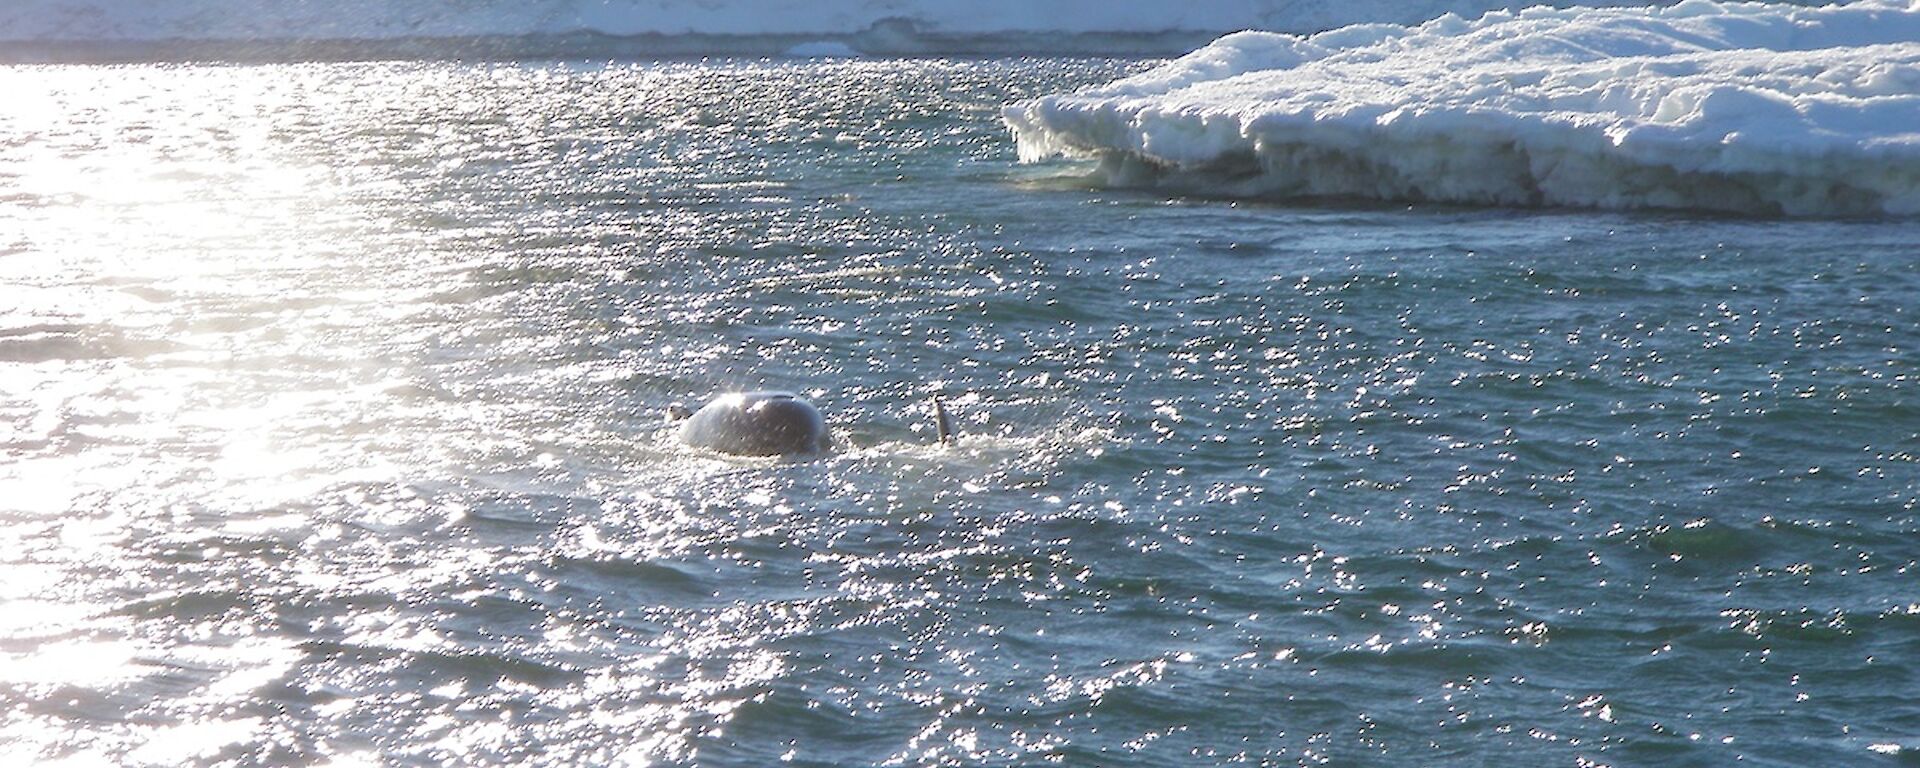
top-left (0, 60), bottom-right (1920, 766)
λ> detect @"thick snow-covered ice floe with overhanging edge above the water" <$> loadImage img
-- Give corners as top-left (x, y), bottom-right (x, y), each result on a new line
top-left (1004, 0), bottom-right (1920, 217)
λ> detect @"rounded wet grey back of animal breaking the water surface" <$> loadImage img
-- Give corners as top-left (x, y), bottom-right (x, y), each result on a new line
top-left (680, 392), bottom-right (831, 455)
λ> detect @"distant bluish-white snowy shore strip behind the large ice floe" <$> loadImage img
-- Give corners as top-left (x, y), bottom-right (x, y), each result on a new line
top-left (0, 0), bottom-right (1689, 43)
